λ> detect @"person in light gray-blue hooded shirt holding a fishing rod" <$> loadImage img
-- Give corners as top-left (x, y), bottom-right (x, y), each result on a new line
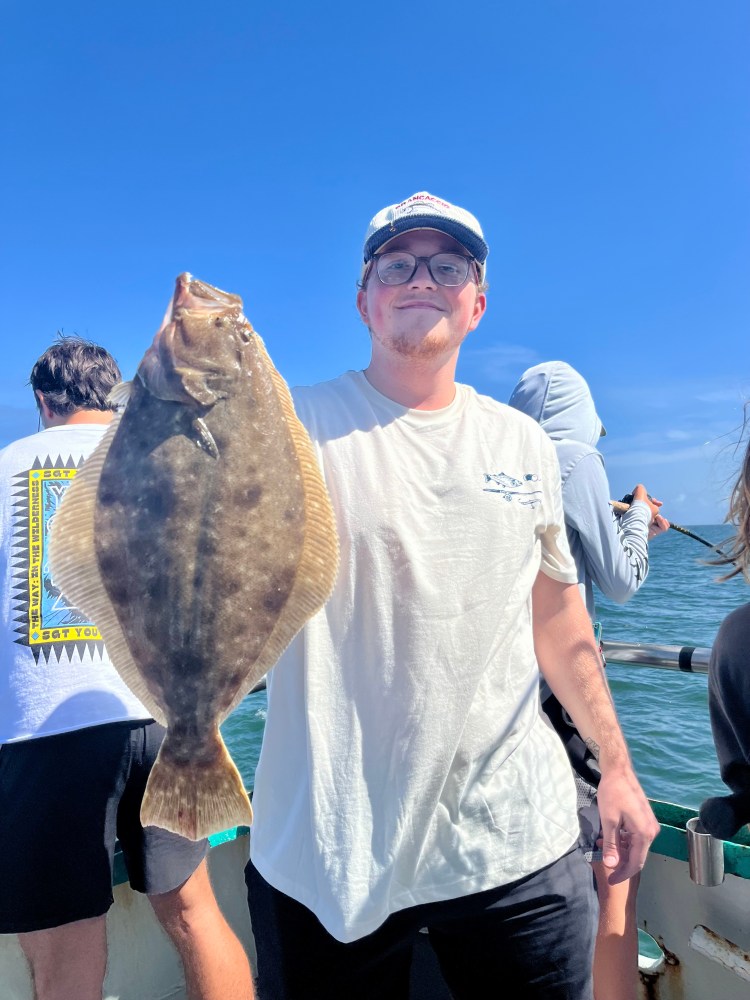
top-left (509, 361), bottom-right (669, 1000)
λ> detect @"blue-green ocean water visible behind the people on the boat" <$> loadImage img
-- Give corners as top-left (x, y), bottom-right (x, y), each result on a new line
top-left (222, 525), bottom-right (750, 807)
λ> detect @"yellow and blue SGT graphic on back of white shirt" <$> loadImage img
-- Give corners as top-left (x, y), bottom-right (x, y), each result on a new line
top-left (12, 457), bottom-right (104, 663)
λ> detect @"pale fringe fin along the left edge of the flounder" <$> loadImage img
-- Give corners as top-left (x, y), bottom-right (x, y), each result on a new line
top-left (49, 412), bottom-right (166, 725)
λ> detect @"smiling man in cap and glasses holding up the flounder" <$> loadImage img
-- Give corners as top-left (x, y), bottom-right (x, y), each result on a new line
top-left (246, 192), bottom-right (658, 1000)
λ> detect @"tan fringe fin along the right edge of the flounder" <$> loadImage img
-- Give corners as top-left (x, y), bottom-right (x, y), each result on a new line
top-left (222, 333), bottom-right (339, 718)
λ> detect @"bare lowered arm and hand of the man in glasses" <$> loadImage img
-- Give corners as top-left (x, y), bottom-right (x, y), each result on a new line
top-left (532, 572), bottom-right (659, 884)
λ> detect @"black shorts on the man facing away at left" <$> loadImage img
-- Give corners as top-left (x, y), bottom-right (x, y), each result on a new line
top-left (0, 721), bottom-right (208, 934)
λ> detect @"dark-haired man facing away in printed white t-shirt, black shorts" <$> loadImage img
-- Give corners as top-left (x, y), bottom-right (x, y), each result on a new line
top-left (0, 337), bottom-right (253, 1000)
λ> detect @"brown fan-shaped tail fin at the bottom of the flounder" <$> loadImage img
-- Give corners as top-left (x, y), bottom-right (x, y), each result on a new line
top-left (141, 729), bottom-right (253, 840)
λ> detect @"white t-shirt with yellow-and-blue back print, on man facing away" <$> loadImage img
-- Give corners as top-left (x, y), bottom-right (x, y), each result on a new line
top-left (0, 424), bottom-right (149, 743)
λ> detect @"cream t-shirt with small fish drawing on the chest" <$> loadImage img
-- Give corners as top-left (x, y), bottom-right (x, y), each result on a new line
top-left (251, 372), bottom-right (578, 941)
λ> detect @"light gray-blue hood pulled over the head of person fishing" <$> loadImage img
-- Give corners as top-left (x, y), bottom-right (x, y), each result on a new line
top-left (508, 361), bottom-right (604, 448)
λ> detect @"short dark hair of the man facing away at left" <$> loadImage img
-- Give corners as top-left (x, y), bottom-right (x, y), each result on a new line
top-left (29, 334), bottom-right (122, 417)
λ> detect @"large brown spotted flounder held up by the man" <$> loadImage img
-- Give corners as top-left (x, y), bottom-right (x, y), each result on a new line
top-left (50, 274), bottom-right (338, 840)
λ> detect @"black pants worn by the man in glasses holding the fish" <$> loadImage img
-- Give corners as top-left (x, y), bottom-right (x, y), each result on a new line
top-left (245, 850), bottom-right (598, 1000)
